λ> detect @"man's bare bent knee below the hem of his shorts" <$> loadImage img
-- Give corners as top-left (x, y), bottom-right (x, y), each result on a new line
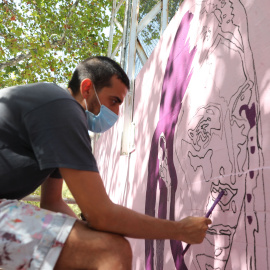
top-left (55, 222), bottom-right (132, 270)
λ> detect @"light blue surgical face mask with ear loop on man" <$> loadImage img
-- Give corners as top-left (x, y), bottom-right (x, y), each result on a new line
top-left (84, 87), bottom-right (118, 133)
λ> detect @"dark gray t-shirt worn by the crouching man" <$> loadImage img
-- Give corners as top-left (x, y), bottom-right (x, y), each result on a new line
top-left (0, 83), bottom-right (98, 199)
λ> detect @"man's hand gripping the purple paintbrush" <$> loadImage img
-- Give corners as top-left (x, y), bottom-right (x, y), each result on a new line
top-left (178, 217), bottom-right (212, 244)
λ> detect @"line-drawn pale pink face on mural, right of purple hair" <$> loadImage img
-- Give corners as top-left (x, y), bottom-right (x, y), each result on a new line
top-left (173, 0), bottom-right (268, 270)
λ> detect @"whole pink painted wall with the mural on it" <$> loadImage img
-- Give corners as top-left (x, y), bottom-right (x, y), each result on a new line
top-left (95, 0), bottom-right (270, 270)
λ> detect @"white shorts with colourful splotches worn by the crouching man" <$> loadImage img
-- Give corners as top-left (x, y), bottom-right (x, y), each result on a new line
top-left (0, 199), bottom-right (76, 270)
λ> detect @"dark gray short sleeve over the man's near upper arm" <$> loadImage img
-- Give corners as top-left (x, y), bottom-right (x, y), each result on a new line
top-left (23, 99), bottom-right (98, 172)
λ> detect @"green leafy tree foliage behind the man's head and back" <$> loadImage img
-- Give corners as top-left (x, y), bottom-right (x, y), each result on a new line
top-left (0, 0), bottom-right (112, 88)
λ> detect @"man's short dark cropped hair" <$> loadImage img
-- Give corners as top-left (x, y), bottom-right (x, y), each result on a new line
top-left (68, 56), bottom-right (129, 94)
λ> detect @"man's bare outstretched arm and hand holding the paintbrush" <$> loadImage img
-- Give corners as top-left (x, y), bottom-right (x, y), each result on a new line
top-left (60, 168), bottom-right (211, 244)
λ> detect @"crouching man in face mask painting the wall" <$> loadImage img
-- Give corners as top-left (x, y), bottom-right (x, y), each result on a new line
top-left (0, 57), bottom-right (211, 269)
